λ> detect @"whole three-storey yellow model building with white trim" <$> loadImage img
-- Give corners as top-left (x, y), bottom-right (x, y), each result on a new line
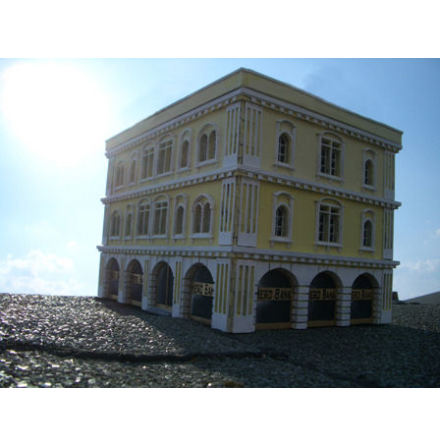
top-left (98, 69), bottom-right (402, 333)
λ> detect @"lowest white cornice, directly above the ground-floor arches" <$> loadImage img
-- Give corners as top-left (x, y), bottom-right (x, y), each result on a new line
top-left (97, 245), bottom-right (400, 269)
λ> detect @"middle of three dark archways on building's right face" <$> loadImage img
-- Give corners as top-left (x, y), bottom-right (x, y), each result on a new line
top-left (308, 271), bottom-right (339, 327)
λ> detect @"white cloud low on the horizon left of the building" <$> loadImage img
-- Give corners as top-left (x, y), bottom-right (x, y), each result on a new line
top-left (0, 250), bottom-right (82, 295)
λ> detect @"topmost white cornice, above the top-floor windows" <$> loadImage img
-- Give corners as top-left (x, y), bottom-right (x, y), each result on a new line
top-left (106, 87), bottom-right (402, 157)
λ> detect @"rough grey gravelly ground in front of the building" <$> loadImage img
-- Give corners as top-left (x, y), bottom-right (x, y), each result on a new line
top-left (0, 294), bottom-right (440, 387)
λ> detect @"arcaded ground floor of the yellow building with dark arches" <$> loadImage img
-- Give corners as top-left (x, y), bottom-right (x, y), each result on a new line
top-left (99, 250), bottom-right (392, 333)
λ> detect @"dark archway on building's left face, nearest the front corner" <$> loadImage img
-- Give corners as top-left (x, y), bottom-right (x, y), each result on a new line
top-left (185, 263), bottom-right (214, 325)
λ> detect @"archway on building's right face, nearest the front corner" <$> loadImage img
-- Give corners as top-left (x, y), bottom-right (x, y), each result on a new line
top-left (256, 269), bottom-right (295, 329)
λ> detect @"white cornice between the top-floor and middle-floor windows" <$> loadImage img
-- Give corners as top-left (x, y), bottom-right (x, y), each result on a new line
top-left (101, 166), bottom-right (401, 209)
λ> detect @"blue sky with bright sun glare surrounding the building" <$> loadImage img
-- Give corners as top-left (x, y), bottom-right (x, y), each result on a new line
top-left (0, 59), bottom-right (440, 299)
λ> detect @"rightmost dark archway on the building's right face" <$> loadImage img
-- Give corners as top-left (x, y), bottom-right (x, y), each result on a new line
top-left (351, 274), bottom-right (377, 325)
